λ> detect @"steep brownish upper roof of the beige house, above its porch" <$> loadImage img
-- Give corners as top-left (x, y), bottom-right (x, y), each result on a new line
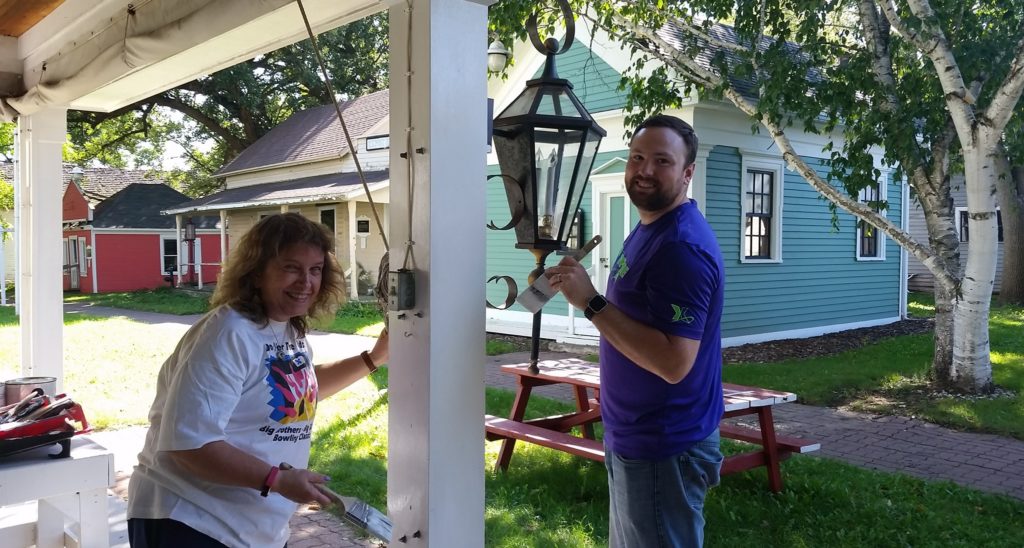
top-left (216, 89), bottom-right (388, 176)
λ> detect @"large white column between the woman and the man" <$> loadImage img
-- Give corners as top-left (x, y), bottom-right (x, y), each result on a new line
top-left (388, 0), bottom-right (492, 548)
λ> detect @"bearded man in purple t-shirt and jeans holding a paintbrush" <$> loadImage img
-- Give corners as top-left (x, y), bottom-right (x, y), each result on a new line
top-left (546, 116), bottom-right (725, 548)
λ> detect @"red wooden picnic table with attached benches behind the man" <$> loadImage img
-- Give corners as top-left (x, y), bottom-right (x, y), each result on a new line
top-left (484, 360), bottom-right (820, 493)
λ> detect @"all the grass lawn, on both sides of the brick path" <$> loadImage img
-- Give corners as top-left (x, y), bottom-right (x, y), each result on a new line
top-left (0, 308), bottom-right (1024, 547)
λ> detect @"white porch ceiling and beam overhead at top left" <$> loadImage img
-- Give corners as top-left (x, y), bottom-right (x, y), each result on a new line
top-left (0, 0), bottom-right (387, 119)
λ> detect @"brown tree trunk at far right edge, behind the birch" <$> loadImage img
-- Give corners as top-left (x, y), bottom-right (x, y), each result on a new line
top-left (996, 161), bottom-right (1024, 306)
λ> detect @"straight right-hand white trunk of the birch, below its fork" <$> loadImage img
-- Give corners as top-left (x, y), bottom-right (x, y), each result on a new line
top-left (949, 145), bottom-right (997, 393)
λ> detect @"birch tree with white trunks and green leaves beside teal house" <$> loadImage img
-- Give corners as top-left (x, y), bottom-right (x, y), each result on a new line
top-left (492, 0), bottom-right (1024, 392)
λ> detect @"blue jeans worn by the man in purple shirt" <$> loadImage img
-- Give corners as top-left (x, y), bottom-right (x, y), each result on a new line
top-left (604, 429), bottom-right (722, 548)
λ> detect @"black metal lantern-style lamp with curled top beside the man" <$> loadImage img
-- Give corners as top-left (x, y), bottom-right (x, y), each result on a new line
top-left (494, 0), bottom-right (606, 374)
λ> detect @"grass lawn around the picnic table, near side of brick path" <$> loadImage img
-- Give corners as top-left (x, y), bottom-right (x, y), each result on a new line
top-left (311, 369), bottom-right (1024, 548)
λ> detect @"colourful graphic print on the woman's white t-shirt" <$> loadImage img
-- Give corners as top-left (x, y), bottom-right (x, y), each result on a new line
top-left (265, 351), bottom-right (316, 424)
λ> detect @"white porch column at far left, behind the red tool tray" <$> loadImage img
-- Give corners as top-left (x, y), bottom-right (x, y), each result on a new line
top-left (16, 109), bottom-right (68, 387)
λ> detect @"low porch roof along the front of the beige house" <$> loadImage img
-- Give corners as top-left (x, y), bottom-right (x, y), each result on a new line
top-left (164, 169), bottom-right (388, 215)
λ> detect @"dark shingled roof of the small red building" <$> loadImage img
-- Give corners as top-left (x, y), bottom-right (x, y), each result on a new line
top-left (92, 183), bottom-right (220, 229)
